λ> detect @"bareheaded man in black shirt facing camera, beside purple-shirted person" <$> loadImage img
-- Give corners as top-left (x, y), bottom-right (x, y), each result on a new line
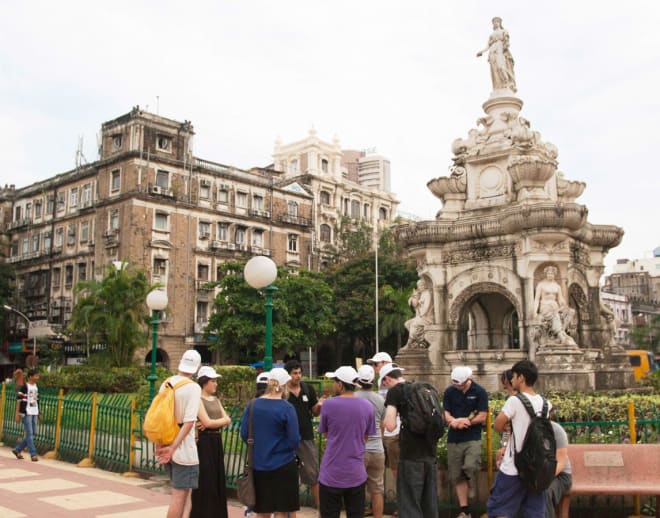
top-left (284, 360), bottom-right (324, 509)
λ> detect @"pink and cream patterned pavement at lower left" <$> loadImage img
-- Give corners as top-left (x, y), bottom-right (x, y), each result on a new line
top-left (0, 446), bottom-right (324, 518)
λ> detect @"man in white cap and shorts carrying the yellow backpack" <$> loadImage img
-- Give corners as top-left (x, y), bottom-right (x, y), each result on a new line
top-left (155, 349), bottom-right (202, 518)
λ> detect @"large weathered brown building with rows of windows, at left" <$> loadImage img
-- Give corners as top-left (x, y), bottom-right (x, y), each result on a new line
top-left (0, 107), bottom-right (315, 367)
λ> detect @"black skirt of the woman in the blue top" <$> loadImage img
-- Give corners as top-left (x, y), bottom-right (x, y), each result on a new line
top-left (253, 459), bottom-right (300, 513)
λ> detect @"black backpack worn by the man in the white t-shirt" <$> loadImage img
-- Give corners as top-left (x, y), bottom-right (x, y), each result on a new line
top-left (513, 394), bottom-right (557, 493)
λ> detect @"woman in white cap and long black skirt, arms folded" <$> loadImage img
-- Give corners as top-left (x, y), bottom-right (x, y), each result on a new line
top-left (190, 367), bottom-right (231, 518)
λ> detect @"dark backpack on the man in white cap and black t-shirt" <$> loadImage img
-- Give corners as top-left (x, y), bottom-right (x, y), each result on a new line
top-left (401, 381), bottom-right (445, 442)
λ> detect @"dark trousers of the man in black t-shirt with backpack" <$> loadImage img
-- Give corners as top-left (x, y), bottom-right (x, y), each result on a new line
top-left (396, 457), bottom-right (438, 518)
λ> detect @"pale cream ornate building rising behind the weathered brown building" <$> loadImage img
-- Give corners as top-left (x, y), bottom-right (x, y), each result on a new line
top-left (273, 130), bottom-right (399, 268)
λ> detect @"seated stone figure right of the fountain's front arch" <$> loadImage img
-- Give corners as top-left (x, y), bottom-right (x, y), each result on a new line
top-left (534, 266), bottom-right (576, 347)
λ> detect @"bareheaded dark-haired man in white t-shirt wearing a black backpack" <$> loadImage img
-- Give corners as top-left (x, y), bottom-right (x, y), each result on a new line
top-left (487, 360), bottom-right (550, 518)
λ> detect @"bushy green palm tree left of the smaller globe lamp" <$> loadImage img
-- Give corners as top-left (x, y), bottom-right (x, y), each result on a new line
top-left (68, 263), bottom-right (158, 367)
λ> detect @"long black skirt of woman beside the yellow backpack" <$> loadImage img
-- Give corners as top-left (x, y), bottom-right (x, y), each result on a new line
top-left (190, 430), bottom-right (228, 518)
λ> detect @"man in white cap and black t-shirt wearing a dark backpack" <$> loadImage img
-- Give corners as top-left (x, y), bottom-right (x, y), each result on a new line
top-left (380, 363), bottom-right (438, 518)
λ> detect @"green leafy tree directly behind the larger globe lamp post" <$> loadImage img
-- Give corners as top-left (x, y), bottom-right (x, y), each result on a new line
top-left (205, 262), bottom-right (335, 361)
